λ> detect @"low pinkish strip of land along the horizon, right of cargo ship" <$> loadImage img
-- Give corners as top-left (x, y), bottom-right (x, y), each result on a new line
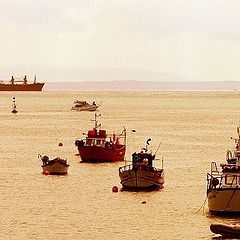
top-left (44, 81), bottom-right (240, 91)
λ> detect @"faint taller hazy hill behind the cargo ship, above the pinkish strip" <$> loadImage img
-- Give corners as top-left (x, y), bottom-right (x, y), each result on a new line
top-left (0, 66), bottom-right (188, 82)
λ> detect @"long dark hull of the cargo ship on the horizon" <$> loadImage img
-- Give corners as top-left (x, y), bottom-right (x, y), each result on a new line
top-left (0, 83), bottom-right (44, 91)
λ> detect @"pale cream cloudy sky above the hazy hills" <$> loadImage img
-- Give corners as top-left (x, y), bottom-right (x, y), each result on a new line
top-left (0, 0), bottom-right (240, 81)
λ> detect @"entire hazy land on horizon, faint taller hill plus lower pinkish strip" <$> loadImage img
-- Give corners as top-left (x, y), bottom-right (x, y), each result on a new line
top-left (0, 66), bottom-right (240, 91)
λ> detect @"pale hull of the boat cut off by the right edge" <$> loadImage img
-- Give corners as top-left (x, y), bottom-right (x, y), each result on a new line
top-left (207, 188), bottom-right (240, 213)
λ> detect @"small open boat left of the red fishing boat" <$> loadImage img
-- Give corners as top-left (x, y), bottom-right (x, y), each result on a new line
top-left (39, 154), bottom-right (70, 175)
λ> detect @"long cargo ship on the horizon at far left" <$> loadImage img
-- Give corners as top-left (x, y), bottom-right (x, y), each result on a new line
top-left (0, 75), bottom-right (45, 91)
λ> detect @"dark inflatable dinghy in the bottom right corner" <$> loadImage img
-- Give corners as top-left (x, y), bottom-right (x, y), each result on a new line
top-left (210, 223), bottom-right (240, 238)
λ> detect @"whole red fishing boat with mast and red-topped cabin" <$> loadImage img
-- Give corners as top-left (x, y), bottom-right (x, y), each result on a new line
top-left (75, 114), bottom-right (126, 162)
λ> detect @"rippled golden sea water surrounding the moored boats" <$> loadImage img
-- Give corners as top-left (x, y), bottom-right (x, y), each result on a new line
top-left (0, 91), bottom-right (240, 240)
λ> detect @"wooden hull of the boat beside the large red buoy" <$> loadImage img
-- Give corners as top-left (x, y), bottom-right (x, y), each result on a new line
top-left (119, 169), bottom-right (164, 188)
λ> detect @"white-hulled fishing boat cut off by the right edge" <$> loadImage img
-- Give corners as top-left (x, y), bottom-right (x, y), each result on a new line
top-left (207, 127), bottom-right (240, 214)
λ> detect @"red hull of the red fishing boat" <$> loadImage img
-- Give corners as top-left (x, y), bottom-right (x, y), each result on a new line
top-left (78, 145), bottom-right (126, 162)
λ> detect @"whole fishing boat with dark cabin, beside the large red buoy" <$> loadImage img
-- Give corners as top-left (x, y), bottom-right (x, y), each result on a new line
top-left (119, 139), bottom-right (164, 189)
